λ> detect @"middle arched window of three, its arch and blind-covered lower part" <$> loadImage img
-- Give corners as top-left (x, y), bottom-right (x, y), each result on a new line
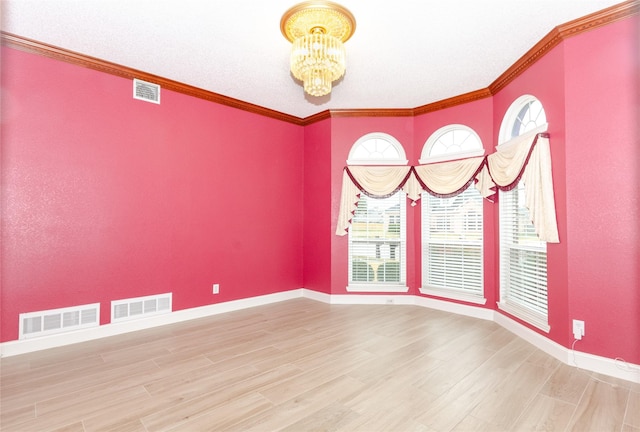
top-left (420, 125), bottom-right (486, 304)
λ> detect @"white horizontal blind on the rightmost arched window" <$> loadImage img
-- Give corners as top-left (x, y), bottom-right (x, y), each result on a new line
top-left (499, 183), bottom-right (548, 329)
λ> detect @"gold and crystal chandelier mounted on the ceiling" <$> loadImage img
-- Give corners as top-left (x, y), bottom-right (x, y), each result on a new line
top-left (280, 1), bottom-right (356, 96)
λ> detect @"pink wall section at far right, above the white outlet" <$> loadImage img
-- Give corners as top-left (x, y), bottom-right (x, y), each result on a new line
top-left (564, 15), bottom-right (640, 364)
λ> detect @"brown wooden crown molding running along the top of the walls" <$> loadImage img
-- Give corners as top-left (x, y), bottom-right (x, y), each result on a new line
top-left (0, 0), bottom-right (640, 126)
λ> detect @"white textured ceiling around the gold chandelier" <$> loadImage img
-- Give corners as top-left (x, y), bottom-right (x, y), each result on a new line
top-left (0, 0), bottom-right (621, 118)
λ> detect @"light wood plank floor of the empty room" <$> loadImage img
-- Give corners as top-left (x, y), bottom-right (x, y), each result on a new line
top-left (0, 299), bottom-right (640, 432)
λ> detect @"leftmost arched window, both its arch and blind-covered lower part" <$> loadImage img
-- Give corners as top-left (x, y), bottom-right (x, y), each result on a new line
top-left (347, 133), bottom-right (408, 292)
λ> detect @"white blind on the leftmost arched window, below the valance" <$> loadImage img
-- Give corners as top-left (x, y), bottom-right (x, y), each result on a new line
top-left (349, 191), bottom-right (406, 290)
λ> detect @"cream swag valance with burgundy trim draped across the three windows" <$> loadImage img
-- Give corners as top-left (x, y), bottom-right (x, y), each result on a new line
top-left (336, 129), bottom-right (559, 243)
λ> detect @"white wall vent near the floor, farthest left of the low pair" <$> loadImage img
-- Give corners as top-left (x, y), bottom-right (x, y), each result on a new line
top-left (18, 303), bottom-right (100, 339)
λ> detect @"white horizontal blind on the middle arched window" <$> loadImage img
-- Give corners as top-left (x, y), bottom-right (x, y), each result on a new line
top-left (422, 185), bottom-right (484, 298)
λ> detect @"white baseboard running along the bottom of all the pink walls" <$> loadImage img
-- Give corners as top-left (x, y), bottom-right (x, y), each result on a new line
top-left (0, 288), bottom-right (640, 383)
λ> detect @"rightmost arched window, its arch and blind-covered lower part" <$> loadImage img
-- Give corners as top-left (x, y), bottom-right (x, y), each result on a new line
top-left (499, 95), bottom-right (550, 332)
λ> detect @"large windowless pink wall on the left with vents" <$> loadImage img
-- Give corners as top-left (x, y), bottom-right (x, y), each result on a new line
top-left (1, 47), bottom-right (304, 341)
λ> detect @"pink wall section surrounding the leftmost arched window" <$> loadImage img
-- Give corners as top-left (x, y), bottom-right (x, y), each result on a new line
top-left (330, 117), bottom-right (420, 294)
